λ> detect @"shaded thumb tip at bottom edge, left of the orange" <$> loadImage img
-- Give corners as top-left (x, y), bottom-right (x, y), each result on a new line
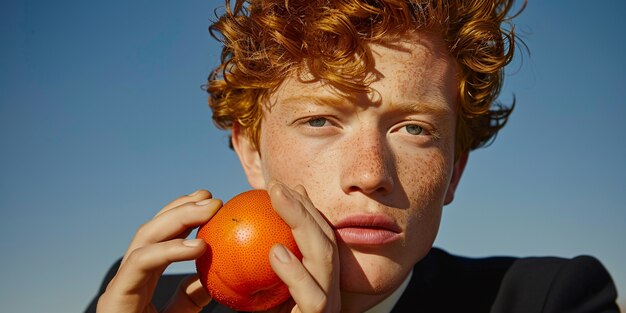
top-left (162, 275), bottom-right (211, 313)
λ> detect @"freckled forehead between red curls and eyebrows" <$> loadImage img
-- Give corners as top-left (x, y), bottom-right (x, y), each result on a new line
top-left (269, 32), bottom-right (458, 109)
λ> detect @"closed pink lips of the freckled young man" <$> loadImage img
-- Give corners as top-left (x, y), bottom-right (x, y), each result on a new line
top-left (333, 214), bottom-right (401, 246)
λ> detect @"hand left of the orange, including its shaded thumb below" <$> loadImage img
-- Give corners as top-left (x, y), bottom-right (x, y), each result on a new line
top-left (97, 190), bottom-right (222, 313)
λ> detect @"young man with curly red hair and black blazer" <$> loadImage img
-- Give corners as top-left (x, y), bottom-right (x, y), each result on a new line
top-left (89, 0), bottom-right (617, 312)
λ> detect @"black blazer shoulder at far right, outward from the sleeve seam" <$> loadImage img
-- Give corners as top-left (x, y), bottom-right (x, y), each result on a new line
top-left (493, 255), bottom-right (619, 312)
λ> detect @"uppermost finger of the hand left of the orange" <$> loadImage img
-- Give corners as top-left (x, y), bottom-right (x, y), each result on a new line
top-left (123, 199), bottom-right (222, 260)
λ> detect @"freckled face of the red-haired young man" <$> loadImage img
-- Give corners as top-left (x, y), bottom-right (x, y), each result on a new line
top-left (241, 33), bottom-right (457, 295)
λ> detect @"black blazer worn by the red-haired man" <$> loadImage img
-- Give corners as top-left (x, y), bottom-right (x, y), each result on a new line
top-left (85, 248), bottom-right (619, 313)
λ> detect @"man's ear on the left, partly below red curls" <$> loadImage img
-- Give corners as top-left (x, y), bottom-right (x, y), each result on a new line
top-left (231, 123), bottom-right (265, 189)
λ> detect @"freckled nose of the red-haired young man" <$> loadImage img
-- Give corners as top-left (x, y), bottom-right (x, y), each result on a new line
top-left (340, 132), bottom-right (395, 195)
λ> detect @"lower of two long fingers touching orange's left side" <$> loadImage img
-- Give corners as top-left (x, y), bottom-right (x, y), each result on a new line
top-left (107, 239), bottom-right (206, 297)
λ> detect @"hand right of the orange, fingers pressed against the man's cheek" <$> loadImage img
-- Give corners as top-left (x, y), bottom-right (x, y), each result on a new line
top-left (269, 183), bottom-right (341, 313)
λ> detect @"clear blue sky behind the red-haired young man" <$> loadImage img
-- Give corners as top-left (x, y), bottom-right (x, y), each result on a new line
top-left (0, 0), bottom-right (626, 312)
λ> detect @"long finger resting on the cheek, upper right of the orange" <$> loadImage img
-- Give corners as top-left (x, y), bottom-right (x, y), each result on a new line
top-left (270, 184), bottom-right (339, 290)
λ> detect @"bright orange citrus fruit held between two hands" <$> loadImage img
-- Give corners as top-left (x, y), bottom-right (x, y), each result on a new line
top-left (196, 190), bottom-right (302, 312)
